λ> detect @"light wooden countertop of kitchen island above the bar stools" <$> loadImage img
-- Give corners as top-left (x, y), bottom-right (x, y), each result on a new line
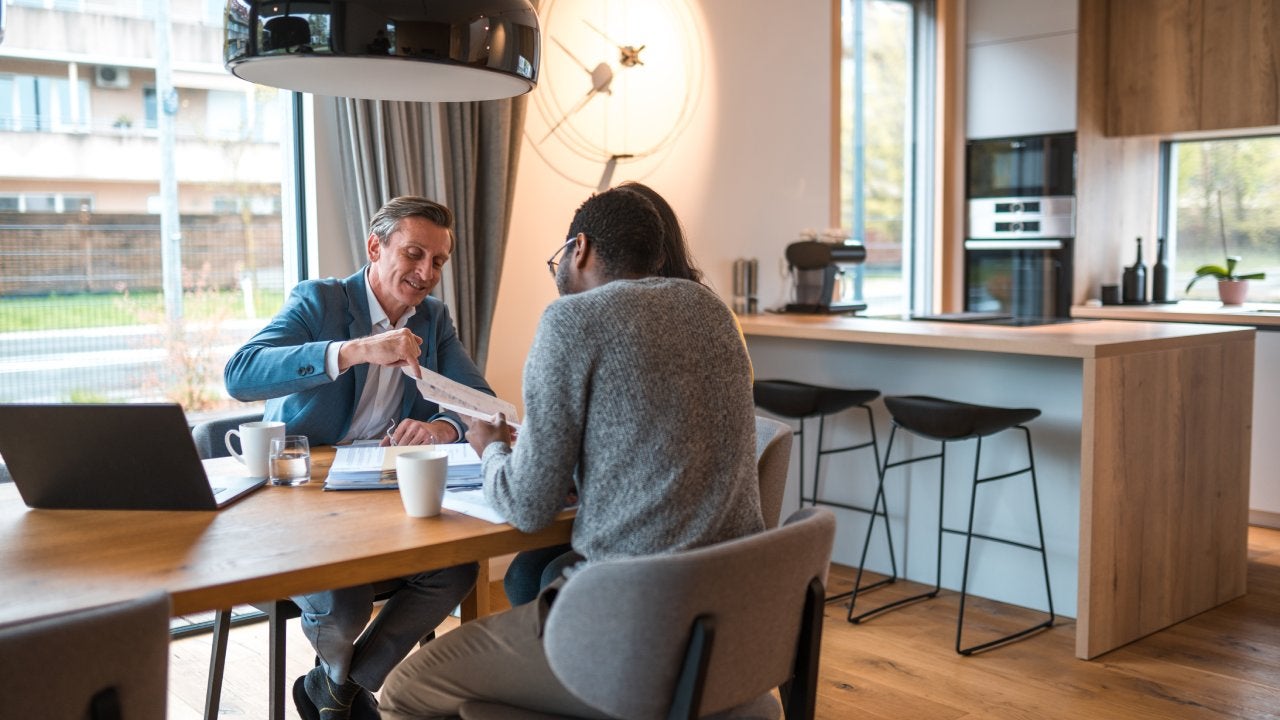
top-left (739, 314), bottom-right (1254, 359)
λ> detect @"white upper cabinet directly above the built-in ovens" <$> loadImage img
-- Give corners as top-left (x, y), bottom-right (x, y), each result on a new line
top-left (965, 0), bottom-right (1078, 140)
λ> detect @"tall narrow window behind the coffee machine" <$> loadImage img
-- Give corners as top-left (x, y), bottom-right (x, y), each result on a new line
top-left (838, 0), bottom-right (932, 314)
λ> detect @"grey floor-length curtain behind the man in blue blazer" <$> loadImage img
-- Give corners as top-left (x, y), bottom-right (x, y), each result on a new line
top-left (338, 97), bottom-right (526, 372)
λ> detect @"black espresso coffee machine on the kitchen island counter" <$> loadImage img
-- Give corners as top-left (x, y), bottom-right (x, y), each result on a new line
top-left (786, 240), bottom-right (867, 313)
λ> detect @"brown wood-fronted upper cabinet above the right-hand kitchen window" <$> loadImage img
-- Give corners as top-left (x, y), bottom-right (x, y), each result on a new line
top-left (1106, 0), bottom-right (1280, 136)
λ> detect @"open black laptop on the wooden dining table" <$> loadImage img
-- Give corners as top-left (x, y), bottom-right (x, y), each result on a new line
top-left (0, 404), bottom-right (266, 510)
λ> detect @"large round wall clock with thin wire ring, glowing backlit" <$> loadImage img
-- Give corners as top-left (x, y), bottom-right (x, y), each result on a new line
top-left (525, 0), bottom-right (703, 190)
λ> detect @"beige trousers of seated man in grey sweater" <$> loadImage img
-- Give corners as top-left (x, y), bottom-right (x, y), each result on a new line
top-left (379, 598), bottom-right (605, 720)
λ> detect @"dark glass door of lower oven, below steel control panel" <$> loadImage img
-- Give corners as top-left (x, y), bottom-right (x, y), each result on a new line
top-left (964, 238), bottom-right (1071, 318)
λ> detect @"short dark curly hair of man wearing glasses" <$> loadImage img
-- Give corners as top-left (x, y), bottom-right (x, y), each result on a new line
top-left (568, 188), bottom-right (666, 278)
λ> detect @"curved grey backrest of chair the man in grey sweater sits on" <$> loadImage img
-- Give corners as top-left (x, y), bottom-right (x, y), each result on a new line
top-left (543, 507), bottom-right (836, 720)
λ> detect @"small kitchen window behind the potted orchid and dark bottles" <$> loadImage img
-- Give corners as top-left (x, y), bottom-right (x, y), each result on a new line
top-left (1164, 136), bottom-right (1280, 302)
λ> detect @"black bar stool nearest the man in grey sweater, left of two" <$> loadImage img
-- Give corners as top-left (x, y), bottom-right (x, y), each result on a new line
top-left (751, 380), bottom-right (897, 602)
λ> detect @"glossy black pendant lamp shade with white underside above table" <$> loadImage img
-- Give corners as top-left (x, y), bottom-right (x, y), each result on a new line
top-left (224, 0), bottom-right (541, 102)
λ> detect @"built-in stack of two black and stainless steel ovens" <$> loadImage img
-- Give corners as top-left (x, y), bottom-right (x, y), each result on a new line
top-left (964, 133), bottom-right (1075, 318)
